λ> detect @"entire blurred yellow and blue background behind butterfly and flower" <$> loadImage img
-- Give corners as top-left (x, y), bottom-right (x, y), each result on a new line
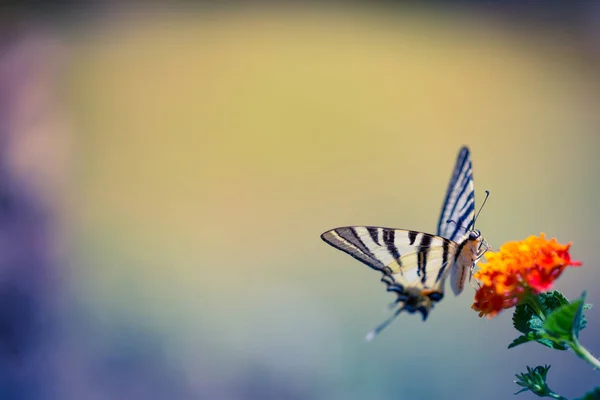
top-left (0, 1), bottom-right (600, 400)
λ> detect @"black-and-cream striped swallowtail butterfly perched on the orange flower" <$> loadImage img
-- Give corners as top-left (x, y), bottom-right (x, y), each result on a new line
top-left (321, 147), bottom-right (489, 341)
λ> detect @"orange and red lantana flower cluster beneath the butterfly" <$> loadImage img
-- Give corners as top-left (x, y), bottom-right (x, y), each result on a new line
top-left (472, 233), bottom-right (581, 317)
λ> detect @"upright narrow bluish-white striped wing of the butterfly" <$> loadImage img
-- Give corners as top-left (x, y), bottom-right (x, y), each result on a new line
top-left (437, 146), bottom-right (475, 242)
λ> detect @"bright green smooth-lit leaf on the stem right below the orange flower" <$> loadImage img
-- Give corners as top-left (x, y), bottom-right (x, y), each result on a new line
top-left (543, 292), bottom-right (586, 343)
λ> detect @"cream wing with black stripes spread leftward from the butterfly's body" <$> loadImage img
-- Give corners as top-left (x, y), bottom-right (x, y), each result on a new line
top-left (321, 226), bottom-right (457, 318)
